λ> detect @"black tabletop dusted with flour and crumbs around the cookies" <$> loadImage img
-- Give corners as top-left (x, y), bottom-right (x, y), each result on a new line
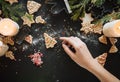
top-left (0, 0), bottom-right (120, 82)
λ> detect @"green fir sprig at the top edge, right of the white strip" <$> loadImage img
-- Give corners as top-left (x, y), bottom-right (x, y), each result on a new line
top-left (68, 0), bottom-right (120, 20)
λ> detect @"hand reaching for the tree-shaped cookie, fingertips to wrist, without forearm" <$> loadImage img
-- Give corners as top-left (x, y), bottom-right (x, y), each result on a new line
top-left (60, 37), bottom-right (95, 69)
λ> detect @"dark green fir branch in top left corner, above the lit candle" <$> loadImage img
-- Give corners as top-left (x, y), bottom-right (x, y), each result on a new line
top-left (0, 0), bottom-right (25, 21)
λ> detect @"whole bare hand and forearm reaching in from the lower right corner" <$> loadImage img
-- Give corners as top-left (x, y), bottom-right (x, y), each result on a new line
top-left (60, 37), bottom-right (120, 82)
